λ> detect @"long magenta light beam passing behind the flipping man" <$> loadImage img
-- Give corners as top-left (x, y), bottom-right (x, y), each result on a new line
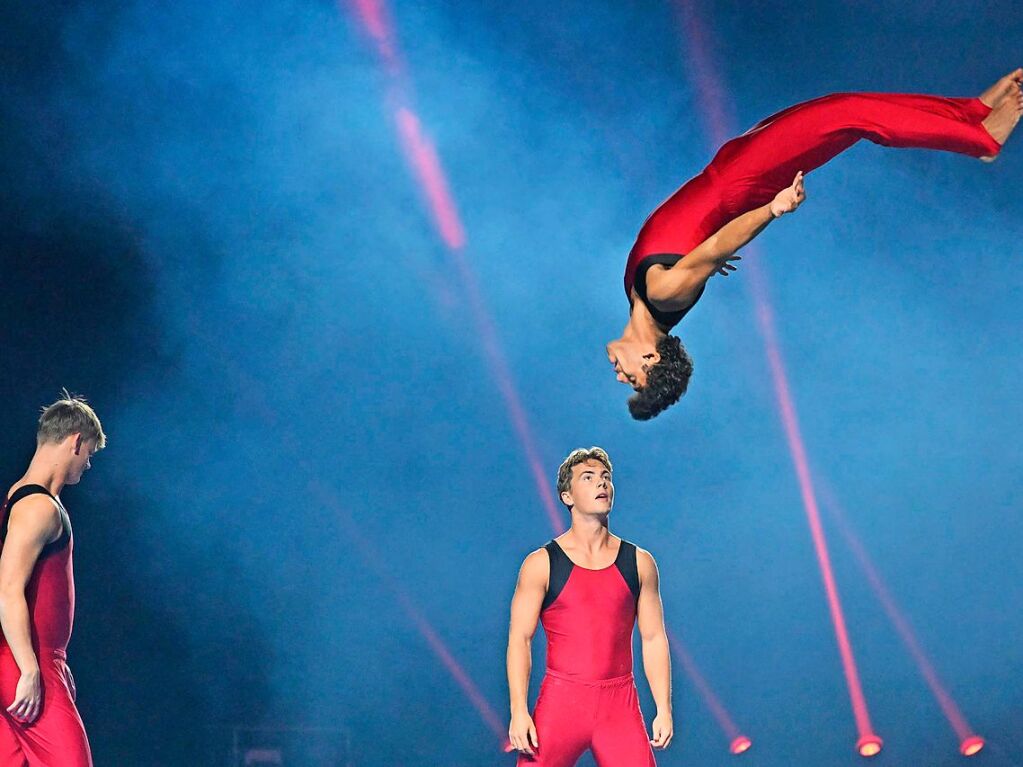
top-left (677, 0), bottom-right (883, 757)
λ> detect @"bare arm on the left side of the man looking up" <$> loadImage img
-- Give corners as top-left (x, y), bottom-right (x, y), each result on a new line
top-left (507, 549), bottom-right (550, 754)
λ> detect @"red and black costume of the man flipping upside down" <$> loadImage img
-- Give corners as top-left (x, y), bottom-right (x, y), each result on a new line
top-left (625, 93), bottom-right (1002, 327)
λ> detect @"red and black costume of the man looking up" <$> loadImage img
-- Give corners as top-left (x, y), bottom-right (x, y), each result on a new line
top-left (519, 541), bottom-right (655, 767)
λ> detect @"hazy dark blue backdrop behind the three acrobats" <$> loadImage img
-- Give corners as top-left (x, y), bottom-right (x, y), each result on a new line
top-left (0, 0), bottom-right (1023, 767)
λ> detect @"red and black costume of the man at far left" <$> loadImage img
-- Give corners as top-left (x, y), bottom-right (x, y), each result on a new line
top-left (0, 485), bottom-right (92, 767)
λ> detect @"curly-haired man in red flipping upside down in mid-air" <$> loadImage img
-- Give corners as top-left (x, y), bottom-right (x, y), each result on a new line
top-left (607, 69), bottom-right (1023, 420)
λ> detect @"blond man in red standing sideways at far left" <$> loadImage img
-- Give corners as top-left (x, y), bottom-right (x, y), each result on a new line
top-left (0, 391), bottom-right (106, 767)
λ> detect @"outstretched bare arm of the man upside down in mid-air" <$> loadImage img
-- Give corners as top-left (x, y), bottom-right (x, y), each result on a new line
top-left (647, 171), bottom-right (806, 311)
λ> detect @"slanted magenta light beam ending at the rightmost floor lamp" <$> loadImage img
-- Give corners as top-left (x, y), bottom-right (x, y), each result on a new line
top-left (820, 485), bottom-right (984, 756)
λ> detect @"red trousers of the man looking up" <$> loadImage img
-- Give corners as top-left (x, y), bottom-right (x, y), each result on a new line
top-left (518, 672), bottom-right (656, 767)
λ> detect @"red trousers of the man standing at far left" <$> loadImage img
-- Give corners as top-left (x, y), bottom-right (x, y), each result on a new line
top-left (0, 647), bottom-right (92, 767)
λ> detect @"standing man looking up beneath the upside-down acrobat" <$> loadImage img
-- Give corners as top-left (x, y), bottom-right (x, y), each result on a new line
top-left (507, 447), bottom-right (673, 767)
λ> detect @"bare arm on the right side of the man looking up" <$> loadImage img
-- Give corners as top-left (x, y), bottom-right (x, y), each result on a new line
top-left (636, 549), bottom-right (674, 749)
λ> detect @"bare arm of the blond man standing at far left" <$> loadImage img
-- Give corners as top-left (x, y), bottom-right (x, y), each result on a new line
top-left (0, 495), bottom-right (61, 722)
